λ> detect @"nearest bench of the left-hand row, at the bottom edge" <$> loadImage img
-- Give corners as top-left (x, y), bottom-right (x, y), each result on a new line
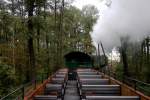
top-left (34, 95), bottom-right (61, 100)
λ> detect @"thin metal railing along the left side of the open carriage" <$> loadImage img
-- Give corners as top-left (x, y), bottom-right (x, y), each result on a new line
top-left (0, 73), bottom-right (49, 100)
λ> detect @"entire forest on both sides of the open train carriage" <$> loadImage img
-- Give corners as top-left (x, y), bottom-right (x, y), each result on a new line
top-left (0, 0), bottom-right (150, 98)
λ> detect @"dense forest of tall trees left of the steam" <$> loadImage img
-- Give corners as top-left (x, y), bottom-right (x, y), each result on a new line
top-left (0, 0), bottom-right (98, 97)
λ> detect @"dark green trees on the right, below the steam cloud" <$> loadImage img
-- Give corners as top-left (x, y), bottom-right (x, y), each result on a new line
top-left (117, 37), bottom-right (150, 83)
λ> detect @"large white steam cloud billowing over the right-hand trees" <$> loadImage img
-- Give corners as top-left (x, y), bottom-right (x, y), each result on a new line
top-left (91, 0), bottom-right (150, 50)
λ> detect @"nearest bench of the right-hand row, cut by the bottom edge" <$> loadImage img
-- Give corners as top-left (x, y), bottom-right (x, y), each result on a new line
top-left (82, 96), bottom-right (140, 100)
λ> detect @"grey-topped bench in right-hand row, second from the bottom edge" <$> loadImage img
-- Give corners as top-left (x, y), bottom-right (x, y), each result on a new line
top-left (80, 85), bottom-right (121, 97)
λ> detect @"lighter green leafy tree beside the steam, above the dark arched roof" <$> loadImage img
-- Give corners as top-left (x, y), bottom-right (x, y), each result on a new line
top-left (64, 5), bottom-right (98, 53)
